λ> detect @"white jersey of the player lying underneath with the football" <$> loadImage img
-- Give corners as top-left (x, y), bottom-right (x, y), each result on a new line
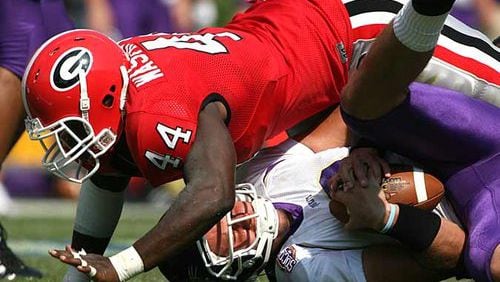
top-left (236, 140), bottom-right (462, 282)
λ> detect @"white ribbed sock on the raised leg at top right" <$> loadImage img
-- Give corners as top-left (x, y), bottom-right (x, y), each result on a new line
top-left (393, 1), bottom-right (448, 52)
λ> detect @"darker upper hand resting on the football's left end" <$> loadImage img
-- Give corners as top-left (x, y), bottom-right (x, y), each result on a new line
top-left (330, 147), bottom-right (391, 191)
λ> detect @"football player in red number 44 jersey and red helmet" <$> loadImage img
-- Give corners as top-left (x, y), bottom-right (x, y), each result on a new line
top-left (23, 0), bottom-right (486, 281)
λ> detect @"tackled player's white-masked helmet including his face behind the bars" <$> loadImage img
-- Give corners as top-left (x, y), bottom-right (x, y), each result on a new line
top-left (197, 183), bottom-right (279, 280)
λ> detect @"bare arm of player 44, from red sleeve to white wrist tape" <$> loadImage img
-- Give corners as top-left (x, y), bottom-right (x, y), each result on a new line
top-left (134, 103), bottom-right (236, 270)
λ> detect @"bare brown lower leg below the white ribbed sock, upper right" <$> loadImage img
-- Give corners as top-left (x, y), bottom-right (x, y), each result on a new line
top-left (342, 25), bottom-right (432, 120)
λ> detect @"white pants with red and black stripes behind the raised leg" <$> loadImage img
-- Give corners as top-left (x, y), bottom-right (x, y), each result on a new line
top-left (343, 0), bottom-right (500, 107)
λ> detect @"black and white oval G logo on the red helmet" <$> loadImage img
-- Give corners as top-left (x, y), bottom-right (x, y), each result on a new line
top-left (50, 47), bottom-right (92, 91)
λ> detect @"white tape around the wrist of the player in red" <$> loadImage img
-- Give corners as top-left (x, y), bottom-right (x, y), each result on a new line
top-left (109, 246), bottom-right (144, 281)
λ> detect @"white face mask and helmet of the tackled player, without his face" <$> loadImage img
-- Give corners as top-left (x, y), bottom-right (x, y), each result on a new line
top-left (197, 183), bottom-right (279, 280)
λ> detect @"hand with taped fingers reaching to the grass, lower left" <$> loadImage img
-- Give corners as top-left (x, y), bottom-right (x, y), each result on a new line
top-left (49, 245), bottom-right (120, 282)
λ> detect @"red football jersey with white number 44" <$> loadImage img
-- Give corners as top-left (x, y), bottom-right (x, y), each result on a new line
top-left (120, 0), bottom-right (352, 186)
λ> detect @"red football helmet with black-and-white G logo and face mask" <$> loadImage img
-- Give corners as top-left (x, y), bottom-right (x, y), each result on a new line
top-left (22, 30), bottom-right (128, 183)
